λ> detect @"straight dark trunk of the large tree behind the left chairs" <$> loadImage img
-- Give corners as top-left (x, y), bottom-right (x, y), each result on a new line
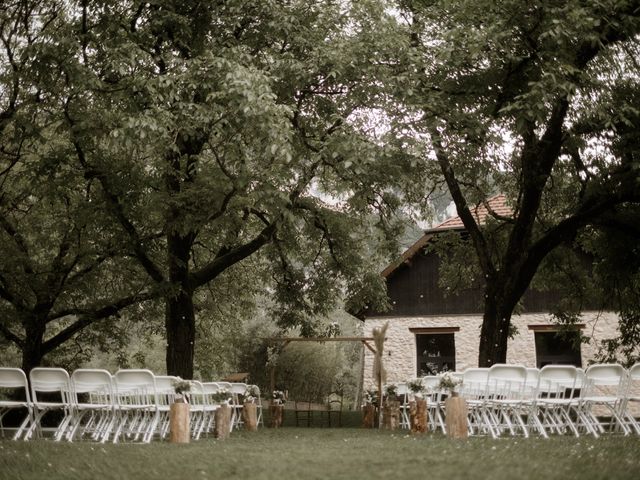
top-left (165, 233), bottom-right (196, 379)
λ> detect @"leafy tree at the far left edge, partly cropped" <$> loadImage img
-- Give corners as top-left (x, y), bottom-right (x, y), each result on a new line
top-left (0, 1), bottom-right (164, 371)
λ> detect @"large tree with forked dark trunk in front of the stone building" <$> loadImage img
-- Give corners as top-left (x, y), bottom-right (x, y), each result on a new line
top-left (396, 0), bottom-right (640, 366)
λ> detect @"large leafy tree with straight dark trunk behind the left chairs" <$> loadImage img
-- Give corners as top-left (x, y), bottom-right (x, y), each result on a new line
top-left (26, 0), bottom-right (419, 378)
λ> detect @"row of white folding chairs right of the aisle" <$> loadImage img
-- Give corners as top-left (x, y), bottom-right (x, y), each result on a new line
top-left (396, 363), bottom-right (640, 438)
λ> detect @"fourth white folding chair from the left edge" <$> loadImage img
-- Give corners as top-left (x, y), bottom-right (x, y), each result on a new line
top-left (113, 369), bottom-right (160, 443)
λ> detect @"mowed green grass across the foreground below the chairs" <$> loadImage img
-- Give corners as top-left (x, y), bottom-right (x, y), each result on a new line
top-left (0, 428), bottom-right (640, 480)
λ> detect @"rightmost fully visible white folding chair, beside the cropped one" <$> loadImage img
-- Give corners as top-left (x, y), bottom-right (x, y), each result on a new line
top-left (581, 363), bottom-right (630, 437)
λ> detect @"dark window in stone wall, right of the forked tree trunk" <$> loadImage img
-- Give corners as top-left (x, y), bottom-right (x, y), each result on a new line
top-left (535, 330), bottom-right (582, 368)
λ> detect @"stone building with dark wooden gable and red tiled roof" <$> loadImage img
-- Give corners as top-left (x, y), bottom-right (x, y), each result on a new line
top-left (362, 195), bottom-right (617, 388)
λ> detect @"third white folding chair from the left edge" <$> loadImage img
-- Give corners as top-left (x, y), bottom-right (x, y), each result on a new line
top-left (66, 368), bottom-right (116, 442)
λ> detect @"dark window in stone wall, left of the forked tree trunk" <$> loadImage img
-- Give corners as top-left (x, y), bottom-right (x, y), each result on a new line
top-left (412, 328), bottom-right (459, 376)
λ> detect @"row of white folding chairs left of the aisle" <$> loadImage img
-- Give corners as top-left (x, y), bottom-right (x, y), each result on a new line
top-left (0, 367), bottom-right (262, 443)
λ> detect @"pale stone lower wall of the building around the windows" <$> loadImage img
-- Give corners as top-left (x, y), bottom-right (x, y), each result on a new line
top-left (363, 312), bottom-right (618, 389)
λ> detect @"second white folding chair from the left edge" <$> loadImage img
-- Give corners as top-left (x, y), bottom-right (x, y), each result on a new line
top-left (24, 367), bottom-right (73, 441)
